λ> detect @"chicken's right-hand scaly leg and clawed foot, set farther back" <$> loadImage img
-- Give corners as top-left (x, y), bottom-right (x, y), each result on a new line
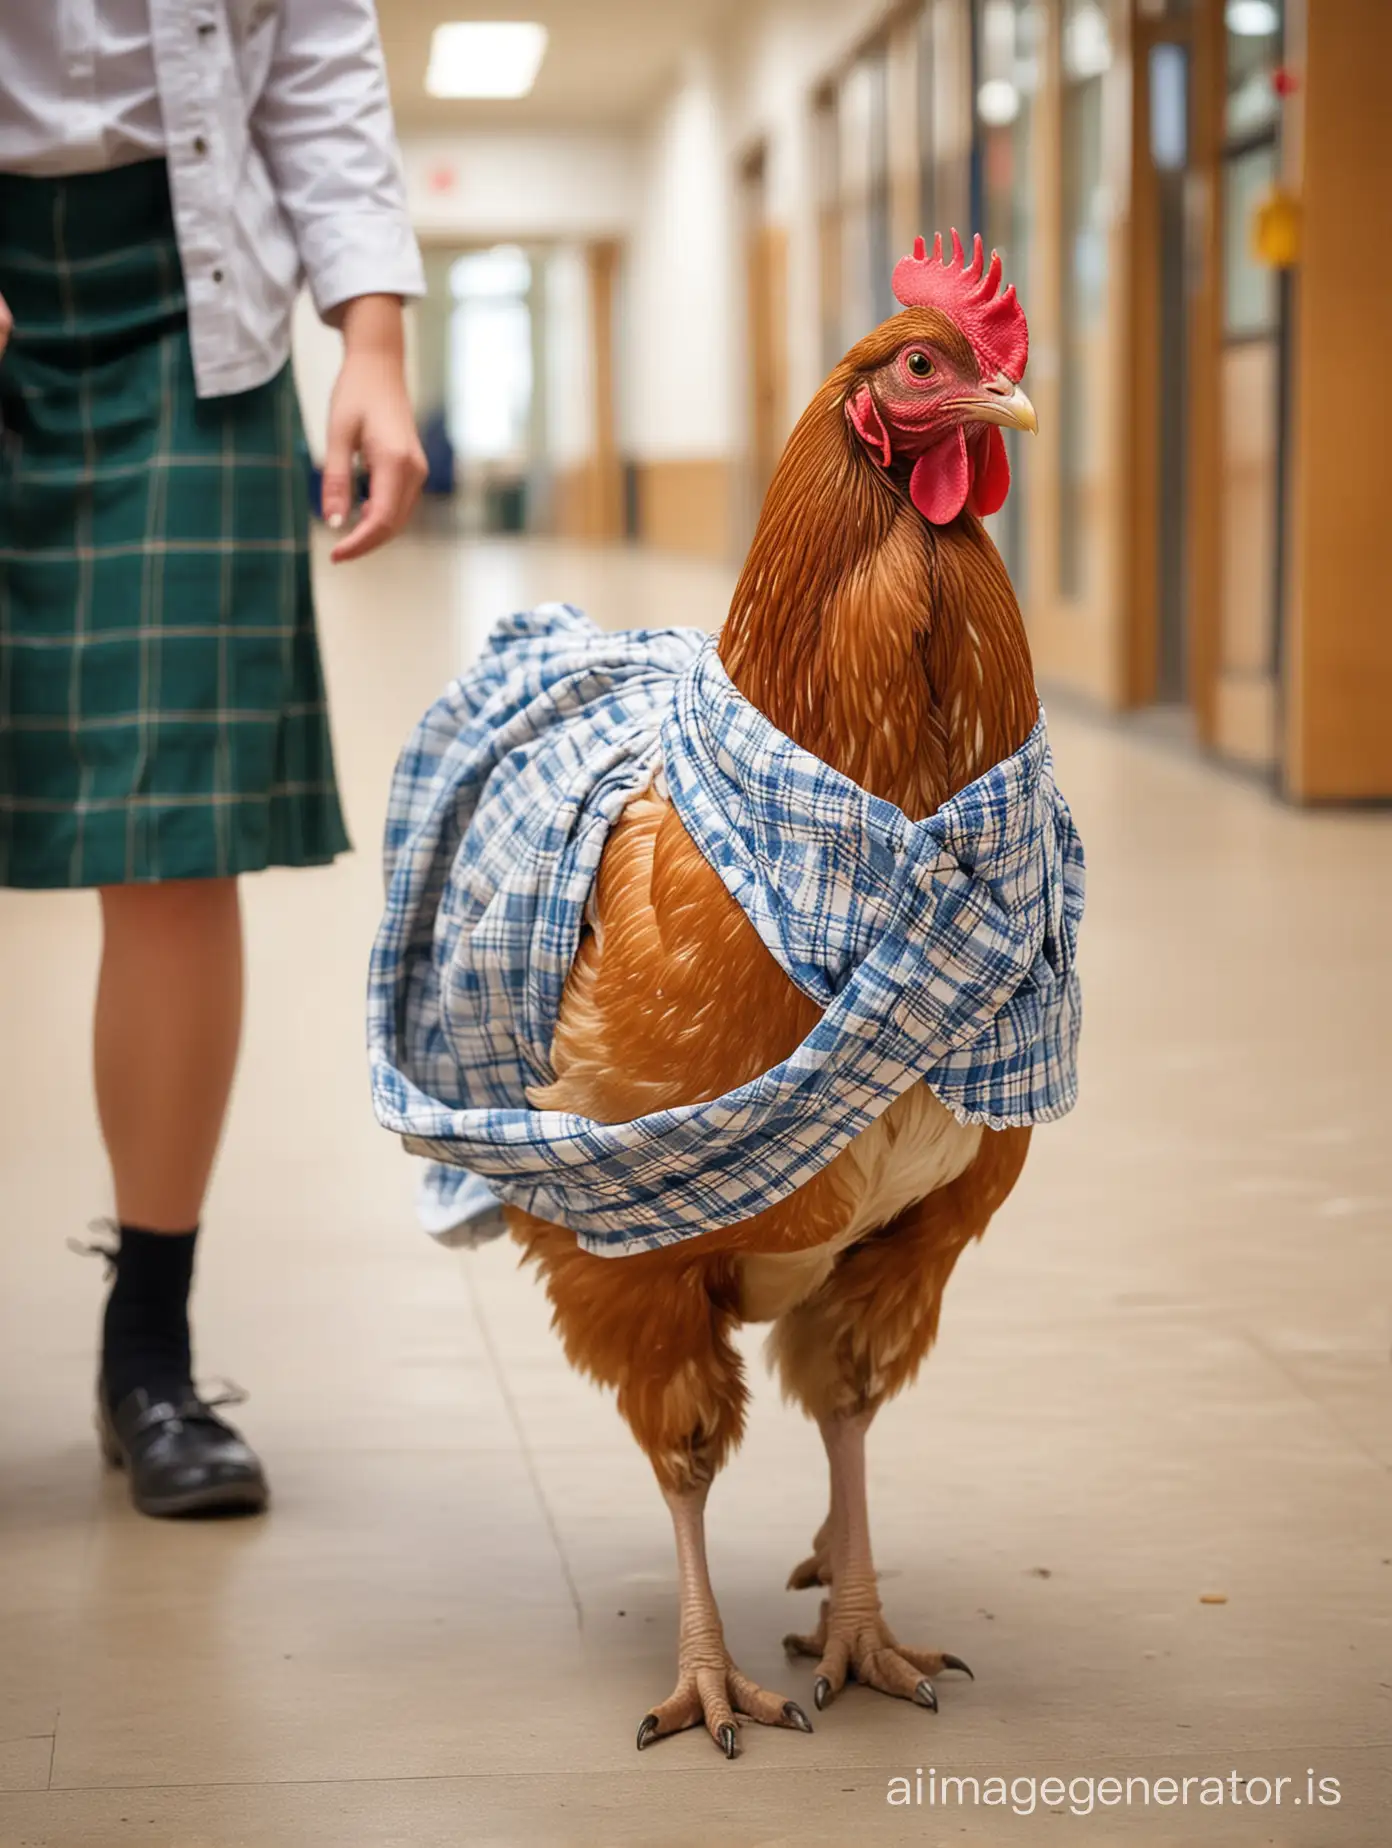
top-left (784, 1414), bottom-right (972, 1711)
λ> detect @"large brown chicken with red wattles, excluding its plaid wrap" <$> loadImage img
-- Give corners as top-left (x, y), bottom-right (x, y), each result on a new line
top-left (508, 238), bottom-right (1037, 1756)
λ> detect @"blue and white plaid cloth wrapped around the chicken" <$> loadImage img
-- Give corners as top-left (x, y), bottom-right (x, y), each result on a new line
top-left (368, 604), bottom-right (1083, 1255)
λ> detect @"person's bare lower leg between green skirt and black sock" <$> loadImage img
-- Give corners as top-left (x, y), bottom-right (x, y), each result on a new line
top-left (94, 880), bottom-right (242, 1233)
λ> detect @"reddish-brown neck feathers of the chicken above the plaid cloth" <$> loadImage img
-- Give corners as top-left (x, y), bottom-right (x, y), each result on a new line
top-left (719, 373), bottom-right (1037, 819)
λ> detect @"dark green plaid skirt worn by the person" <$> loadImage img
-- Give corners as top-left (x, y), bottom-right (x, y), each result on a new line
top-left (0, 161), bottom-right (348, 887)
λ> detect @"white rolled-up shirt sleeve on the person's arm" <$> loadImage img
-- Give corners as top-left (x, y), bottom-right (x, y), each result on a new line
top-left (251, 0), bottom-right (425, 314)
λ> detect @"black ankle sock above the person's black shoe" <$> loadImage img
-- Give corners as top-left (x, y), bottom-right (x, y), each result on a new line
top-left (102, 1225), bottom-right (198, 1406)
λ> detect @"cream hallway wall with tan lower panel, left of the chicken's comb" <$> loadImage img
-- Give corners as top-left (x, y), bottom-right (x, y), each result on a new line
top-left (617, 0), bottom-right (885, 558)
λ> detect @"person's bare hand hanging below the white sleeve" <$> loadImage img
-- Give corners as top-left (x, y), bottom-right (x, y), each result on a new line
top-left (322, 296), bottom-right (425, 564)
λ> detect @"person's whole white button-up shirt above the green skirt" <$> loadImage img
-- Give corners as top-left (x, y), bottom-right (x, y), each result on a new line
top-left (0, 0), bottom-right (425, 397)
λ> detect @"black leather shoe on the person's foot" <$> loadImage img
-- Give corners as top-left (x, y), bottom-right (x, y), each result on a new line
top-left (96, 1386), bottom-right (270, 1515)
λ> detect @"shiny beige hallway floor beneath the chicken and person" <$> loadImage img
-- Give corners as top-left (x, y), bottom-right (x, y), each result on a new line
top-left (0, 540), bottom-right (1392, 1848)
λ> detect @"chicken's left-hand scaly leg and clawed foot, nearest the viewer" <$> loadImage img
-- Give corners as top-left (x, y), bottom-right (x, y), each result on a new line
top-left (638, 1482), bottom-right (812, 1757)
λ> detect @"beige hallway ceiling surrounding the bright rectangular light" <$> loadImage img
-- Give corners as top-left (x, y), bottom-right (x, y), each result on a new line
top-left (377, 0), bottom-right (747, 133)
